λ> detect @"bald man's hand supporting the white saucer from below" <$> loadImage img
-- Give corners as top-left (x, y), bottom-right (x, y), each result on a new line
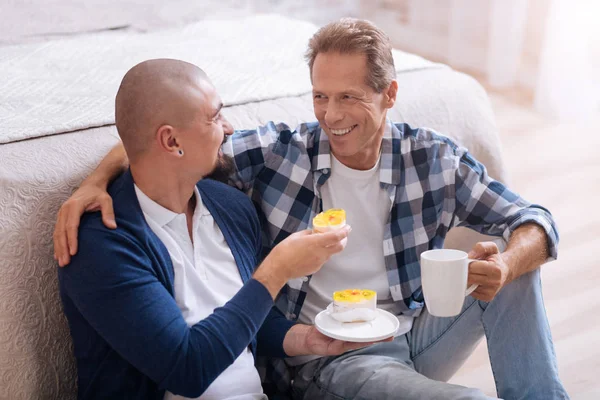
top-left (283, 324), bottom-right (394, 357)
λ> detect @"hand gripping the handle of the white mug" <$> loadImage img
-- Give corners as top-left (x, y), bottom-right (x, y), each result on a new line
top-left (467, 242), bottom-right (512, 302)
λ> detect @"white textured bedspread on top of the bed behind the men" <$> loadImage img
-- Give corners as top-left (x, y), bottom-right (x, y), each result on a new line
top-left (0, 15), bottom-right (441, 143)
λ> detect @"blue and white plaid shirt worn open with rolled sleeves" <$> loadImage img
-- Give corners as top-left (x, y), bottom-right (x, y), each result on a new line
top-left (224, 120), bottom-right (558, 390)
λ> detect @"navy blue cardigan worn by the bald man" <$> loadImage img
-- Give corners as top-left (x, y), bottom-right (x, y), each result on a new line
top-left (58, 171), bottom-right (292, 399)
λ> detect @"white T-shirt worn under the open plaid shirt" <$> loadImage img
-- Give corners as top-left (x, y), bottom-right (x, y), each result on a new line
top-left (288, 155), bottom-right (413, 364)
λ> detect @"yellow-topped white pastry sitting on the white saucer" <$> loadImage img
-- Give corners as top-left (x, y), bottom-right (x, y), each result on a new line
top-left (330, 289), bottom-right (377, 322)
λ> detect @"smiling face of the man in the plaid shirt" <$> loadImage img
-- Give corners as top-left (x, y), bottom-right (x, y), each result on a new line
top-left (312, 52), bottom-right (398, 170)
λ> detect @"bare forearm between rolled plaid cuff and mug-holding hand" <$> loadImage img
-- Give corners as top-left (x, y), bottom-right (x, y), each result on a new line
top-left (502, 223), bottom-right (549, 280)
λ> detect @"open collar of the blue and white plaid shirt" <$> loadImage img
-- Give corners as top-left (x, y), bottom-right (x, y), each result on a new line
top-left (312, 118), bottom-right (402, 185)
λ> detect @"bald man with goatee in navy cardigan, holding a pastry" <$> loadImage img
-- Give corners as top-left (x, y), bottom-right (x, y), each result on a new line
top-left (58, 60), bottom-right (376, 399)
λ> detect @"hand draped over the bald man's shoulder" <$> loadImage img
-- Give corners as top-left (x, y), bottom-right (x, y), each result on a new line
top-left (54, 184), bottom-right (117, 267)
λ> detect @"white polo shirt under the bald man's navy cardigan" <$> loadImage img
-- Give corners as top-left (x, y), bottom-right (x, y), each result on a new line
top-left (135, 185), bottom-right (266, 400)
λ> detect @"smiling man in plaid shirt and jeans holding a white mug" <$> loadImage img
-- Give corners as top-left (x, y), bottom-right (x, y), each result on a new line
top-left (55, 19), bottom-right (568, 400)
